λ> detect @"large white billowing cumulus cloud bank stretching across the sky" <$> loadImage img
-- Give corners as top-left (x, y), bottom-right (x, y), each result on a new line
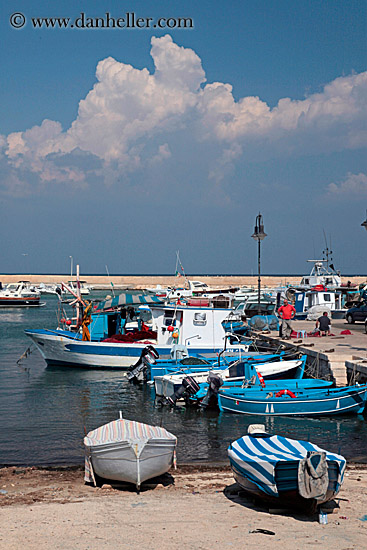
top-left (0, 35), bottom-right (367, 193)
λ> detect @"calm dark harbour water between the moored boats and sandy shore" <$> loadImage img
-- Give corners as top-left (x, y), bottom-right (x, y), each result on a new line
top-left (0, 296), bottom-right (367, 466)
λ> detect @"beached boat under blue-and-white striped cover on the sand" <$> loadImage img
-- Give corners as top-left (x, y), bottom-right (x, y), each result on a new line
top-left (228, 425), bottom-right (346, 512)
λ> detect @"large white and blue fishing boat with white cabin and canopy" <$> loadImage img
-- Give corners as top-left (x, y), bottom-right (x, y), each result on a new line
top-left (25, 294), bottom-right (247, 369)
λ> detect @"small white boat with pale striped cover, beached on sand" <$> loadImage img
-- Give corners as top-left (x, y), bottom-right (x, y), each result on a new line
top-left (84, 412), bottom-right (177, 490)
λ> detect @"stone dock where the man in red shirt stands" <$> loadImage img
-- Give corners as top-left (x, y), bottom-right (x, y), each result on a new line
top-left (254, 319), bottom-right (367, 386)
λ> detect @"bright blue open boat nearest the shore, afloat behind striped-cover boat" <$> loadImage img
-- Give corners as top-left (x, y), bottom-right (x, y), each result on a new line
top-left (218, 384), bottom-right (367, 416)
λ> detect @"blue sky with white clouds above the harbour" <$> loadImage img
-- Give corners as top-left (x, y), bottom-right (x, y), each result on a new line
top-left (0, 0), bottom-right (367, 275)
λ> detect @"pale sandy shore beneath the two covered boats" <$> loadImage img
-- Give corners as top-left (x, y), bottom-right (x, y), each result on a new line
top-left (0, 465), bottom-right (367, 550)
